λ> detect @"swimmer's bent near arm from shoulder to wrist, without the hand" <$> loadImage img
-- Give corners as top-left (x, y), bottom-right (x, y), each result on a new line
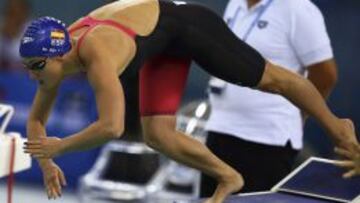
top-left (61, 33), bottom-right (128, 153)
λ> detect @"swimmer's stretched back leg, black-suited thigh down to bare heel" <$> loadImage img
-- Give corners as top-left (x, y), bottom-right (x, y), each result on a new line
top-left (179, 2), bottom-right (358, 164)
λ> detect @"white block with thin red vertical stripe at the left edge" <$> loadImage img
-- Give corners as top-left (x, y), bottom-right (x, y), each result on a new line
top-left (0, 133), bottom-right (31, 178)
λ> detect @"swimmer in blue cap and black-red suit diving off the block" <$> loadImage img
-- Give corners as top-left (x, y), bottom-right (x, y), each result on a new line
top-left (20, 0), bottom-right (357, 203)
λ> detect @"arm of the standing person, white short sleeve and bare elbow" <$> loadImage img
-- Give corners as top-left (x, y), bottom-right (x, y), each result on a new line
top-left (288, 1), bottom-right (337, 120)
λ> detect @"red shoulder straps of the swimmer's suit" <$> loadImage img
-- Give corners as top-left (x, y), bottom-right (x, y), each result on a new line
top-left (69, 16), bottom-right (136, 59)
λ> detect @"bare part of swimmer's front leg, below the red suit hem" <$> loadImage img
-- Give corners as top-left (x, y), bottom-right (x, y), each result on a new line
top-left (142, 115), bottom-right (244, 203)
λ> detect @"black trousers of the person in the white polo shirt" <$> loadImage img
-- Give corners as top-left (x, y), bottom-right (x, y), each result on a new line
top-left (200, 132), bottom-right (298, 197)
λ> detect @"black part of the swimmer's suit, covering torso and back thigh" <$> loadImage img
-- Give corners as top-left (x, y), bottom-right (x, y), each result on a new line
top-left (126, 0), bottom-right (266, 87)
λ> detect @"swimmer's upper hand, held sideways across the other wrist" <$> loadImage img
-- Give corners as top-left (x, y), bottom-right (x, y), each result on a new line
top-left (24, 137), bottom-right (62, 159)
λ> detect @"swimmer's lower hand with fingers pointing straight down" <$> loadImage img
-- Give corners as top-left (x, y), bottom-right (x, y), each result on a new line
top-left (40, 161), bottom-right (66, 199)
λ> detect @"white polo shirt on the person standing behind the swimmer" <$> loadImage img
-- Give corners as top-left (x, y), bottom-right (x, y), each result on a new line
top-left (206, 0), bottom-right (333, 149)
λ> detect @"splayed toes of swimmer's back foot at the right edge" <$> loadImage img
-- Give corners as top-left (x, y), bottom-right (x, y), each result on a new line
top-left (335, 145), bottom-right (360, 178)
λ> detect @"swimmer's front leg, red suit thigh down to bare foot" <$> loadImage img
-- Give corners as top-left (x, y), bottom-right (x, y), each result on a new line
top-left (140, 58), bottom-right (243, 203)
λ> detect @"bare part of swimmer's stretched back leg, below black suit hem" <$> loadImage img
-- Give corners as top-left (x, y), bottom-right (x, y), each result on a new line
top-left (258, 63), bottom-right (358, 150)
